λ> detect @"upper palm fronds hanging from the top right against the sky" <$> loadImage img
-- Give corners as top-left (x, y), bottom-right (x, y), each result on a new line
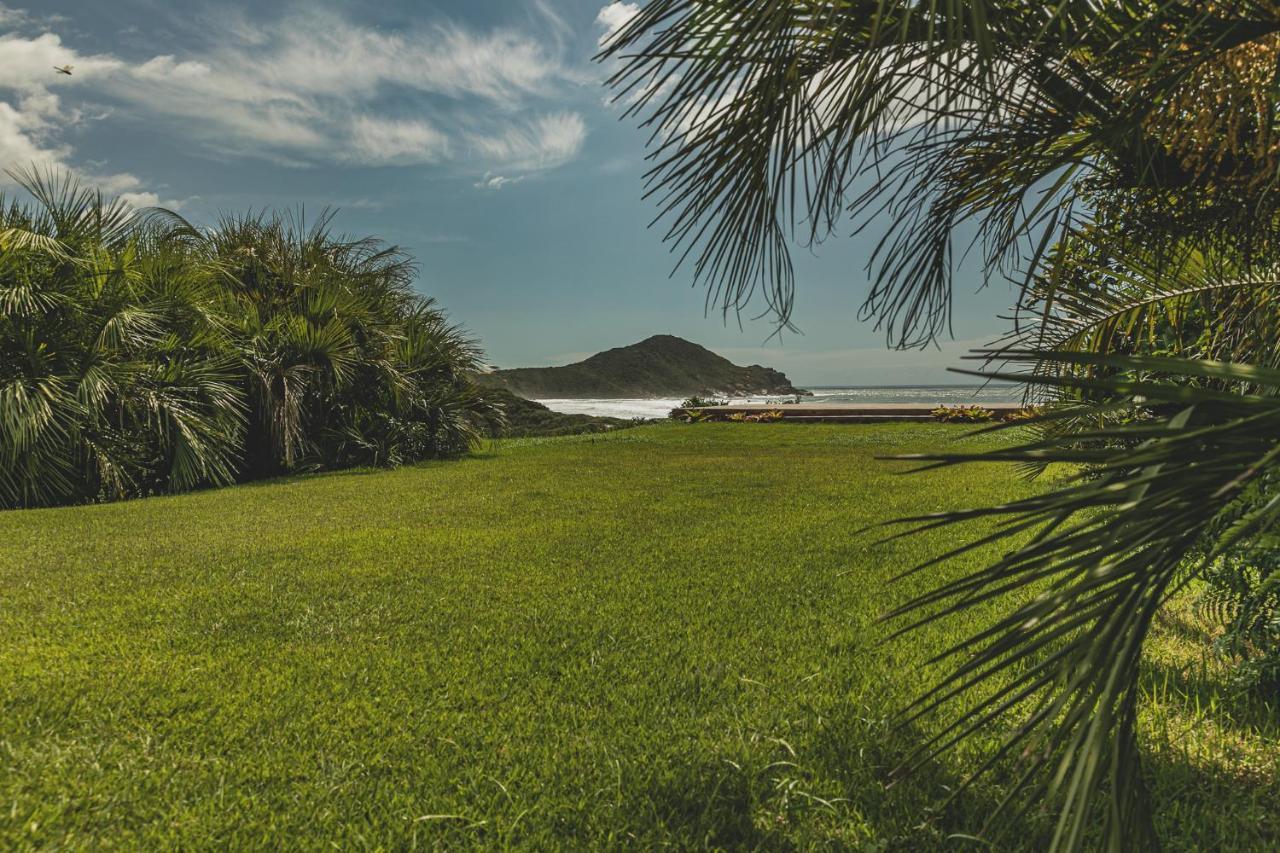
top-left (602, 0), bottom-right (1280, 346)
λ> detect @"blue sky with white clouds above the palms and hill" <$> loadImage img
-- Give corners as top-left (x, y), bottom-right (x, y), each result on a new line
top-left (0, 0), bottom-right (1012, 386)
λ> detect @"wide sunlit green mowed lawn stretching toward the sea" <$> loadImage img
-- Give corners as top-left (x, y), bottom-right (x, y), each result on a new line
top-left (0, 424), bottom-right (1280, 849)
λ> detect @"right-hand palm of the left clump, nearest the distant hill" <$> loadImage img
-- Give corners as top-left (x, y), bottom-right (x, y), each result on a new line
top-left (152, 204), bottom-right (499, 479)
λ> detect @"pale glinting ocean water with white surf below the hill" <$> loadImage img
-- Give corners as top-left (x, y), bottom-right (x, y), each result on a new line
top-left (538, 383), bottom-right (1023, 418)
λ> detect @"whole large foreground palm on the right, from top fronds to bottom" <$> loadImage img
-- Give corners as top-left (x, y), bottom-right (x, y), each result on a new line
top-left (602, 0), bottom-right (1280, 849)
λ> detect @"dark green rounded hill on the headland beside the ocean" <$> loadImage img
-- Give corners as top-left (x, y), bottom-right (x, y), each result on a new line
top-left (479, 334), bottom-right (804, 400)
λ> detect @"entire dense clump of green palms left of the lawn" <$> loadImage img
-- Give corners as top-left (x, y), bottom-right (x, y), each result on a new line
top-left (0, 174), bottom-right (498, 507)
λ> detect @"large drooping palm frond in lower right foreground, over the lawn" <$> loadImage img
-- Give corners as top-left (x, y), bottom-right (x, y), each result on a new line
top-left (890, 351), bottom-right (1280, 849)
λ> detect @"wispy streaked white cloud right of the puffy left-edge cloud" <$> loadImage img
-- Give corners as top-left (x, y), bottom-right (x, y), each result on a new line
top-left (109, 14), bottom-right (564, 165)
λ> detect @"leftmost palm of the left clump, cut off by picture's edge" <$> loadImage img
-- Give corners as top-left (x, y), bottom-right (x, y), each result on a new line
top-left (0, 172), bottom-right (243, 506)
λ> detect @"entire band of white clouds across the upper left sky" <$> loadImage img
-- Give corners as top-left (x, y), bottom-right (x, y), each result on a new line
top-left (0, 4), bottom-right (586, 198)
